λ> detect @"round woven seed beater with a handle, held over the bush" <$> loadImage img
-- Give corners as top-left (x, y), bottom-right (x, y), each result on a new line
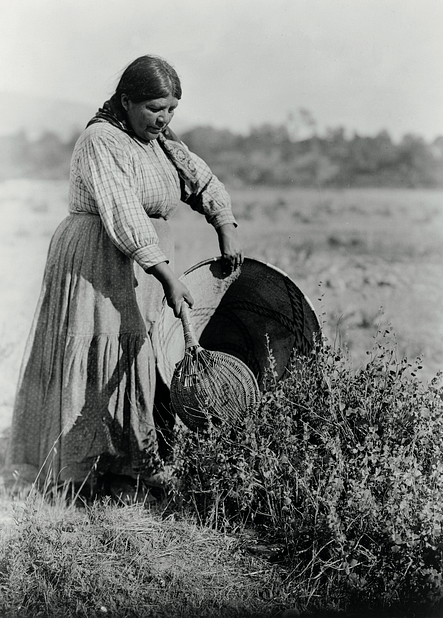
top-left (171, 304), bottom-right (260, 430)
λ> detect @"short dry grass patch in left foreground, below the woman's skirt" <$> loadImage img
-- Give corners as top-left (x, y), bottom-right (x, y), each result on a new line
top-left (0, 482), bottom-right (294, 618)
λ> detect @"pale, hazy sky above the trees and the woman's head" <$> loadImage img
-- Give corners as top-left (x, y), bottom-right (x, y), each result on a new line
top-left (0, 0), bottom-right (443, 140)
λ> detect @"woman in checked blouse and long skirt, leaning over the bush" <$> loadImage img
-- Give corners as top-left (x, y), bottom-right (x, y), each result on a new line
top-left (8, 56), bottom-right (243, 494)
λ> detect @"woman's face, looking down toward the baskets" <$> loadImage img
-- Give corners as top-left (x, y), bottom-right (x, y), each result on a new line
top-left (121, 94), bottom-right (178, 142)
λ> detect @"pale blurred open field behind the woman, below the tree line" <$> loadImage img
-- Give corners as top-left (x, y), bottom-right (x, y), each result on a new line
top-left (0, 180), bottom-right (443, 430)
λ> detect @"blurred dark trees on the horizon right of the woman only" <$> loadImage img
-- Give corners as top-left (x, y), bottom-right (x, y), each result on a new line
top-left (182, 125), bottom-right (443, 187)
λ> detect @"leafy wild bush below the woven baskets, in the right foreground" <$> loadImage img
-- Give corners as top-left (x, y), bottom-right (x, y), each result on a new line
top-left (175, 331), bottom-right (443, 613)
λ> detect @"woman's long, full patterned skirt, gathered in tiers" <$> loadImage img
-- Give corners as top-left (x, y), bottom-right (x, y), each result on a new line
top-left (7, 214), bottom-right (173, 483)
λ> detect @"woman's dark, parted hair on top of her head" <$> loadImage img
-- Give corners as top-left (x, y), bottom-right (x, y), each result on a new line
top-left (114, 56), bottom-right (182, 103)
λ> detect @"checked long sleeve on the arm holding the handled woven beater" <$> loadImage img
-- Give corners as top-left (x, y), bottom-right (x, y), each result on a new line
top-left (79, 131), bottom-right (167, 270)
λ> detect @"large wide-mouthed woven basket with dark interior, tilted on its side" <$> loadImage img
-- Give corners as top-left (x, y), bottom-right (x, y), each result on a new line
top-left (153, 258), bottom-right (321, 391)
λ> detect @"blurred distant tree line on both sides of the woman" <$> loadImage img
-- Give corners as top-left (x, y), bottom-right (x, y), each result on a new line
top-left (0, 124), bottom-right (443, 187)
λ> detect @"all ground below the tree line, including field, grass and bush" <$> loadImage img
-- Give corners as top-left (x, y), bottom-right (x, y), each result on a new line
top-left (0, 180), bottom-right (443, 618)
